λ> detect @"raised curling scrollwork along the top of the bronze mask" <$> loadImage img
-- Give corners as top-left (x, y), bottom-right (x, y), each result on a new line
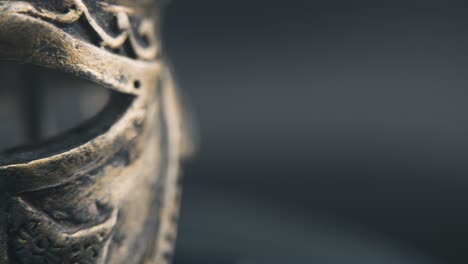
top-left (0, 0), bottom-right (158, 60)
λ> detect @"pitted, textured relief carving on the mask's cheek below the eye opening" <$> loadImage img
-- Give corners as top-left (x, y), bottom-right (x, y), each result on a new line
top-left (10, 198), bottom-right (117, 264)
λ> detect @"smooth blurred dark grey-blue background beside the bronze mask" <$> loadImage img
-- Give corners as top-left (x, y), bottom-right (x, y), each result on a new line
top-left (164, 0), bottom-right (468, 264)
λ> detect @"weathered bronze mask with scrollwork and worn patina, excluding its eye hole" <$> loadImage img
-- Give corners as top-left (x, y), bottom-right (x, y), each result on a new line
top-left (0, 0), bottom-right (191, 264)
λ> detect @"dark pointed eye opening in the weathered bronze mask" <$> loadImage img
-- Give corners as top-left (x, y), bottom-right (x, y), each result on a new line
top-left (0, 61), bottom-right (133, 163)
